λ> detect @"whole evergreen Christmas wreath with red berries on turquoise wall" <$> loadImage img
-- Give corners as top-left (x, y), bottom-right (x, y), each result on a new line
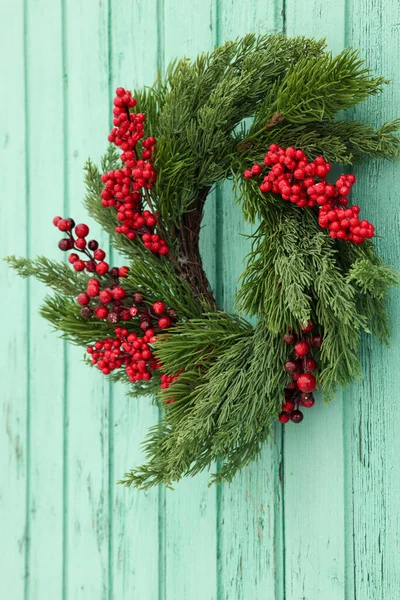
top-left (7, 35), bottom-right (400, 488)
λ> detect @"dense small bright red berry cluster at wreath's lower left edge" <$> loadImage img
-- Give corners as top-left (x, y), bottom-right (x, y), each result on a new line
top-left (87, 327), bottom-right (158, 382)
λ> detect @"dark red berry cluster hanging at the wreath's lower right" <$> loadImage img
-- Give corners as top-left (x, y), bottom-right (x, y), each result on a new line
top-left (278, 323), bottom-right (322, 423)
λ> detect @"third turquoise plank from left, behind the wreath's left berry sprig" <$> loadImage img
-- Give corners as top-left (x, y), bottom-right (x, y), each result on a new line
top-left (63, 0), bottom-right (112, 599)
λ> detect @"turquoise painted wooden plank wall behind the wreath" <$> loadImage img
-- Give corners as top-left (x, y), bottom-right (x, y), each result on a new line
top-left (0, 0), bottom-right (400, 600)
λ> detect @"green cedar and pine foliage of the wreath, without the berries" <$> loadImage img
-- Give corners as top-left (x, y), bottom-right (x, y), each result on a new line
top-left (8, 34), bottom-right (400, 488)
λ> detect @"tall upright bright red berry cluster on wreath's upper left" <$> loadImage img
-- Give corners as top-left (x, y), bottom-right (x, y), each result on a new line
top-left (101, 88), bottom-right (169, 255)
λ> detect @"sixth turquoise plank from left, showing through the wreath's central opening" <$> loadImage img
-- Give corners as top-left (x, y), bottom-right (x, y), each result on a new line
top-left (218, 0), bottom-right (283, 600)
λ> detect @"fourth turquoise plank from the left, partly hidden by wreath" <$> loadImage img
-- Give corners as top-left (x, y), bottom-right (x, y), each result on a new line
top-left (110, 0), bottom-right (164, 599)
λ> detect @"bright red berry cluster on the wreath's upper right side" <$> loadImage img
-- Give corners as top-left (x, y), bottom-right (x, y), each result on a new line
top-left (244, 144), bottom-right (374, 244)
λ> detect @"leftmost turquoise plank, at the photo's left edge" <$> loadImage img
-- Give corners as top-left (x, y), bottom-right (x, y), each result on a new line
top-left (0, 1), bottom-right (29, 600)
